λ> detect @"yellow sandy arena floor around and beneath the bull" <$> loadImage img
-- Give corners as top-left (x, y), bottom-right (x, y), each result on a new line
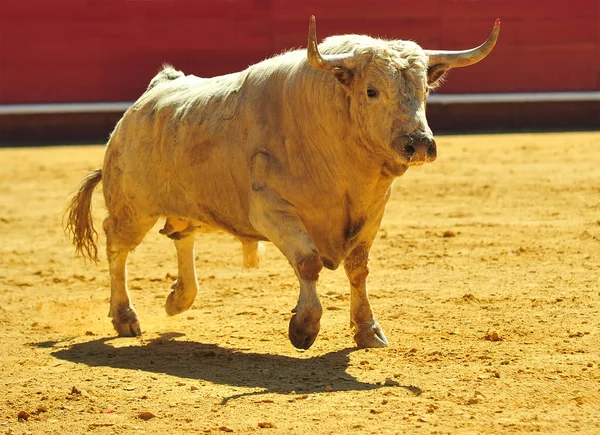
top-left (0, 133), bottom-right (600, 434)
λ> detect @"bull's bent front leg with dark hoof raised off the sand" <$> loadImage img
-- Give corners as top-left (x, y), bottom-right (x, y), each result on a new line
top-left (250, 189), bottom-right (323, 349)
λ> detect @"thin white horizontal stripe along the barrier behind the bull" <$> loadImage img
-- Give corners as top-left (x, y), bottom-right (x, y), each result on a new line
top-left (0, 91), bottom-right (600, 116)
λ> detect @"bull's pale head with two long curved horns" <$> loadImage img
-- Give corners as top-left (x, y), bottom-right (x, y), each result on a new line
top-left (308, 17), bottom-right (500, 173)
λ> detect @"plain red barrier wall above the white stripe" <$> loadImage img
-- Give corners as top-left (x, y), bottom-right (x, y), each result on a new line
top-left (0, 0), bottom-right (600, 104)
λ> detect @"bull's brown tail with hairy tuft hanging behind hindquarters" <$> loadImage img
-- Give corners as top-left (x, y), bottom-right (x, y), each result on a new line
top-left (64, 169), bottom-right (102, 263)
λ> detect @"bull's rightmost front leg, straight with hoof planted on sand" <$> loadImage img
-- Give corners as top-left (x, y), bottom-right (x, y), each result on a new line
top-left (344, 245), bottom-right (388, 347)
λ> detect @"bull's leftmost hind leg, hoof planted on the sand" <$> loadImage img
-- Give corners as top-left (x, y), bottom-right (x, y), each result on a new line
top-left (104, 215), bottom-right (156, 337)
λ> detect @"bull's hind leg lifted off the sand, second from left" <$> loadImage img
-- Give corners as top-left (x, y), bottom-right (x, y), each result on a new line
top-left (160, 218), bottom-right (198, 316)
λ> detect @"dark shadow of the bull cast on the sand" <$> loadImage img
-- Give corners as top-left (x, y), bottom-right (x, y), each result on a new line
top-left (36, 333), bottom-right (421, 402)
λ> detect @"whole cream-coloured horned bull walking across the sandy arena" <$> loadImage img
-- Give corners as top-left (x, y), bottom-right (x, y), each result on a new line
top-left (65, 17), bottom-right (500, 349)
